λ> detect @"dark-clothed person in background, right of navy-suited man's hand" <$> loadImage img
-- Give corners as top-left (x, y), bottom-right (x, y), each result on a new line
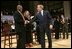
top-left (54, 16), bottom-right (60, 39)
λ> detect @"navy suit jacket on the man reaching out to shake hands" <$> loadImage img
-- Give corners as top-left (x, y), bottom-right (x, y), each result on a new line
top-left (33, 11), bottom-right (53, 26)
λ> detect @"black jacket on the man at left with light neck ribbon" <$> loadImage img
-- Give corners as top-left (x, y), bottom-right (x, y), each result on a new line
top-left (14, 11), bottom-right (24, 33)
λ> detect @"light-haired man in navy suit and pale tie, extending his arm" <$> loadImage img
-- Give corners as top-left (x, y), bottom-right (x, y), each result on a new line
top-left (32, 5), bottom-right (53, 48)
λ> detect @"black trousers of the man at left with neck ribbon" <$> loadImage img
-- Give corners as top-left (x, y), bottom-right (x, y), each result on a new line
top-left (17, 32), bottom-right (26, 48)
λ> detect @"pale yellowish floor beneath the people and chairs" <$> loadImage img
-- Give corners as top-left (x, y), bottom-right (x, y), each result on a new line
top-left (1, 34), bottom-right (71, 48)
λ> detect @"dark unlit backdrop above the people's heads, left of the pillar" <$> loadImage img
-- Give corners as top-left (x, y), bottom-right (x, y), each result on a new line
top-left (1, 1), bottom-right (63, 15)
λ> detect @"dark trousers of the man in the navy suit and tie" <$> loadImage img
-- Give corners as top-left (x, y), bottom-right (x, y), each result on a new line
top-left (39, 26), bottom-right (52, 48)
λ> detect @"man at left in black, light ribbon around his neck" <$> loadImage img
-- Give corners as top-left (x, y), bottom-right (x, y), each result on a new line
top-left (14, 5), bottom-right (26, 48)
